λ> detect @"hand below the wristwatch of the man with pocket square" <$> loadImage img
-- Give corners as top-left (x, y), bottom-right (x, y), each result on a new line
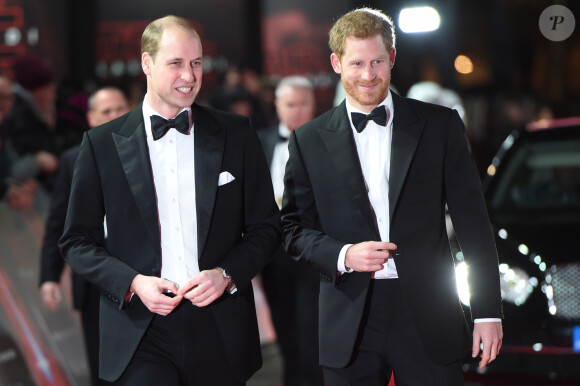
top-left (178, 268), bottom-right (228, 307)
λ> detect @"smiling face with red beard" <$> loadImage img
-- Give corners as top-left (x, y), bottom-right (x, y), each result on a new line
top-left (330, 35), bottom-right (396, 113)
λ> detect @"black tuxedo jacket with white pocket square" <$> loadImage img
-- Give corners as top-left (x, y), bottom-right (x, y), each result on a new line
top-left (60, 104), bottom-right (281, 381)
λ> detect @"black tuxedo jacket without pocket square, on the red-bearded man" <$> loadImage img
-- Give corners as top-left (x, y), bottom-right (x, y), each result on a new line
top-left (282, 93), bottom-right (502, 367)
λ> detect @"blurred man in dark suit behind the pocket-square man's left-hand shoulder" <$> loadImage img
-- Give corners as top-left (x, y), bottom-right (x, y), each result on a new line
top-left (40, 87), bottom-right (129, 385)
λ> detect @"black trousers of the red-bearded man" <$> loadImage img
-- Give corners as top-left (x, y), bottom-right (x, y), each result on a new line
top-left (324, 279), bottom-right (464, 386)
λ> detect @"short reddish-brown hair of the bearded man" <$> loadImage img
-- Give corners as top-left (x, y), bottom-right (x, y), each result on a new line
top-left (328, 8), bottom-right (395, 59)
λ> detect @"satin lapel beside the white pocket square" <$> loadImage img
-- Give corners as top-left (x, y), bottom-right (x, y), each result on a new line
top-left (192, 105), bottom-right (226, 257)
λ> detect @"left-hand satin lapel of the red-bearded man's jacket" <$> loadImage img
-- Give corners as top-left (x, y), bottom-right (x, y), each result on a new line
top-left (318, 102), bottom-right (379, 239)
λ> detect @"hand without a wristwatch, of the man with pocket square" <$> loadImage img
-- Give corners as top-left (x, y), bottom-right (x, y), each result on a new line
top-left (130, 274), bottom-right (182, 316)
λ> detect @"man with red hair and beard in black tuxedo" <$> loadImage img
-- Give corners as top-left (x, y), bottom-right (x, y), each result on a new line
top-left (282, 8), bottom-right (502, 386)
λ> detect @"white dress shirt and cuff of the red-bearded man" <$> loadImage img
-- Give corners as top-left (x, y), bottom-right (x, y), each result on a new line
top-left (337, 92), bottom-right (398, 279)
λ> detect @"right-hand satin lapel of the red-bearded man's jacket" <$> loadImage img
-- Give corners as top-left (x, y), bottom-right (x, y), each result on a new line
top-left (389, 93), bottom-right (425, 221)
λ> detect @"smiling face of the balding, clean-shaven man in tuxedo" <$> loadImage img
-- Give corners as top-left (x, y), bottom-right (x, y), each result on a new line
top-left (141, 25), bottom-right (203, 118)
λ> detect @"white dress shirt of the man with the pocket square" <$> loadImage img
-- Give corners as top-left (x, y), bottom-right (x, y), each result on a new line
top-left (143, 100), bottom-right (199, 286)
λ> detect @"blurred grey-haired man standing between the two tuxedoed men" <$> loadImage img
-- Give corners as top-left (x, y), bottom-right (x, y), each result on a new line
top-left (260, 76), bottom-right (323, 386)
